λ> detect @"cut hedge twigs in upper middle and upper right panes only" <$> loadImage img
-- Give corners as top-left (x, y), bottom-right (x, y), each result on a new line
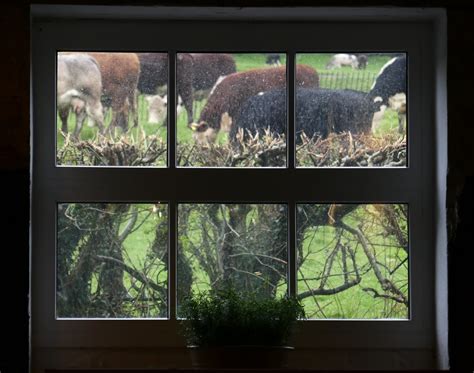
top-left (178, 130), bottom-right (406, 167)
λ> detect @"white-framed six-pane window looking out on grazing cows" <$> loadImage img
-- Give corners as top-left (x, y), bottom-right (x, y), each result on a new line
top-left (32, 7), bottom-right (443, 370)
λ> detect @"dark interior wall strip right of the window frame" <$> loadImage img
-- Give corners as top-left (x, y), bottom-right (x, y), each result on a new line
top-left (447, 8), bottom-right (474, 372)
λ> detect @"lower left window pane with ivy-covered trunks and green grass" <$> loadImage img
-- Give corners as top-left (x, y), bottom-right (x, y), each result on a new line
top-left (56, 203), bottom-right (168, 318)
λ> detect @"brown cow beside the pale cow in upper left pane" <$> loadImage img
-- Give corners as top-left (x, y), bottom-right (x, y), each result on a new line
top-left (88, 52), bottom-right (140, 133)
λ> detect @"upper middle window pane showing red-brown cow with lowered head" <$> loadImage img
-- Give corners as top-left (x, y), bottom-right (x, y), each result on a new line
top-left (177, 53), bottom-right (296, 167)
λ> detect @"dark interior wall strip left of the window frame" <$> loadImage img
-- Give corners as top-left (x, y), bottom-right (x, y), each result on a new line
top-left (0, 5), bottom-right (30, 373)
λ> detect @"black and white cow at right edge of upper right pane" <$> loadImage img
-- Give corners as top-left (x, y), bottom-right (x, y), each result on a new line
top-left (369, 56), bottom-right (407, 133)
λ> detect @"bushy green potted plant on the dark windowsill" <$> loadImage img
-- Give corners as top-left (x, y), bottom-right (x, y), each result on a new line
top-left (181, 286), bottom-right (305, 368)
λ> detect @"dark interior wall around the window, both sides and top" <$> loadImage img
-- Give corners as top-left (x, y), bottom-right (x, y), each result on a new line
top-left (0, 1), bottom-right (474, 373)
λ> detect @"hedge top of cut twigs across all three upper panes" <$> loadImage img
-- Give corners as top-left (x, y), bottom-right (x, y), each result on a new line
top-left (57, 130), bottom-right (407, 167)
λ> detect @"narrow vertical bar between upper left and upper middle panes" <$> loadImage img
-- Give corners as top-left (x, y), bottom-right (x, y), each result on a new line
top-left (167, 50), bottom-right (178, 168)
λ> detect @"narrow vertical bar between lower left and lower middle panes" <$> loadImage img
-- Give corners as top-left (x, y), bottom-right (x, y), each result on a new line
top-left (168, 201), bottom-right (178, 320)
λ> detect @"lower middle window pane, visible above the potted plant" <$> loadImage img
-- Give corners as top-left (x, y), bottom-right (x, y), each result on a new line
top-left (178, 203), bottom-right (288, 306)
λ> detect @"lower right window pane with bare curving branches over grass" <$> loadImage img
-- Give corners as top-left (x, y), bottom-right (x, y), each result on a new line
top-left (296, 204), bottom-right (409, 319)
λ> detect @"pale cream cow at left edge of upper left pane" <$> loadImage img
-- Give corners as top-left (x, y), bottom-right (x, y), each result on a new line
top-left (57, 54), bottom-right (104, 139)
